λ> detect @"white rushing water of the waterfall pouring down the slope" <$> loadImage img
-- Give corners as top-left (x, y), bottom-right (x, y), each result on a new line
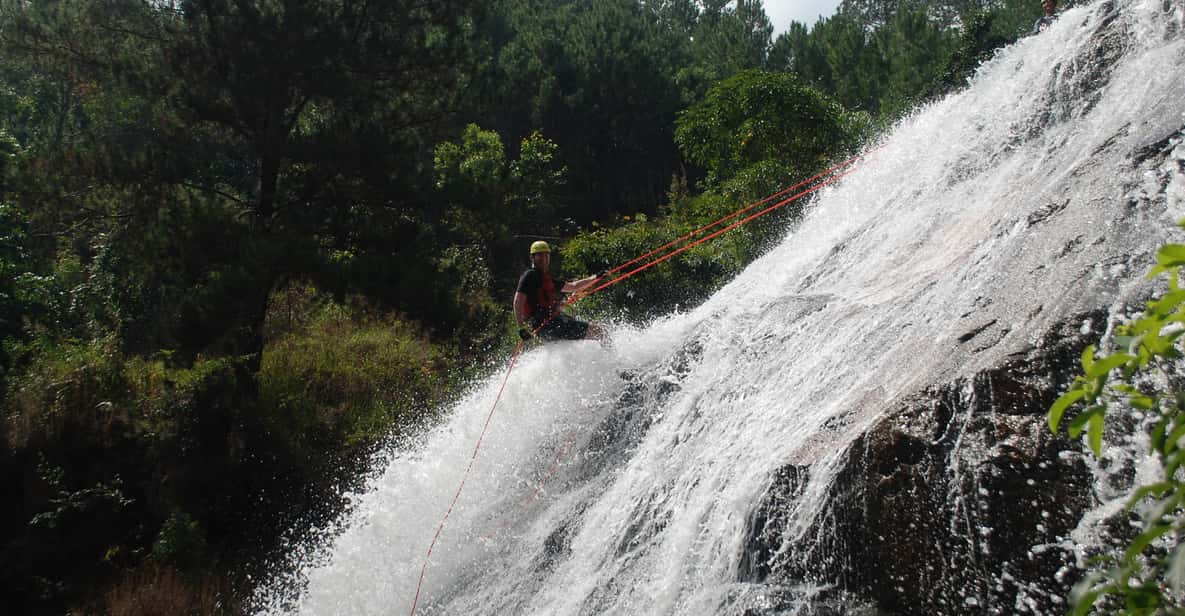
top-left (274, 0), bottom-right (1185, 615)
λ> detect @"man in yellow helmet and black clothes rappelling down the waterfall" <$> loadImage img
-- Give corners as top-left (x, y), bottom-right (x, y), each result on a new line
top-left (514, 240), bottom-right (606, 340)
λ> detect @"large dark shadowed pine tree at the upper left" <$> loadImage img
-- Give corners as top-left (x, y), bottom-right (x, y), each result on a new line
top-left (2, 0), bottom-right (485, 365)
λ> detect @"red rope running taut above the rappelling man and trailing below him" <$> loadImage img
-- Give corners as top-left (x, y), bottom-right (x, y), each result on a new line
top-left (411, 148), bottom-right (879, 616)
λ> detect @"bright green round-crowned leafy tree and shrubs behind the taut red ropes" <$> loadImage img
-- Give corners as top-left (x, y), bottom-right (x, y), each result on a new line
top-left (563, 71), bottom-right (866, 320)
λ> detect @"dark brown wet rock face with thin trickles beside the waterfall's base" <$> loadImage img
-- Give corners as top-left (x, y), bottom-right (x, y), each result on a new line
top-left (739, 314), bottom-right (1103, 615)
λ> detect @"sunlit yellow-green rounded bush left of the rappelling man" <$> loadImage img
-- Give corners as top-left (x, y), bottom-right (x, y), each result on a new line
top-left (260, 291), bottom-right (455, 454)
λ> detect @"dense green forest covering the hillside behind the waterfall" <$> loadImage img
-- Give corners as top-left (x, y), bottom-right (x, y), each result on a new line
top-left (0, 0), bottom-right (1057, 614)
